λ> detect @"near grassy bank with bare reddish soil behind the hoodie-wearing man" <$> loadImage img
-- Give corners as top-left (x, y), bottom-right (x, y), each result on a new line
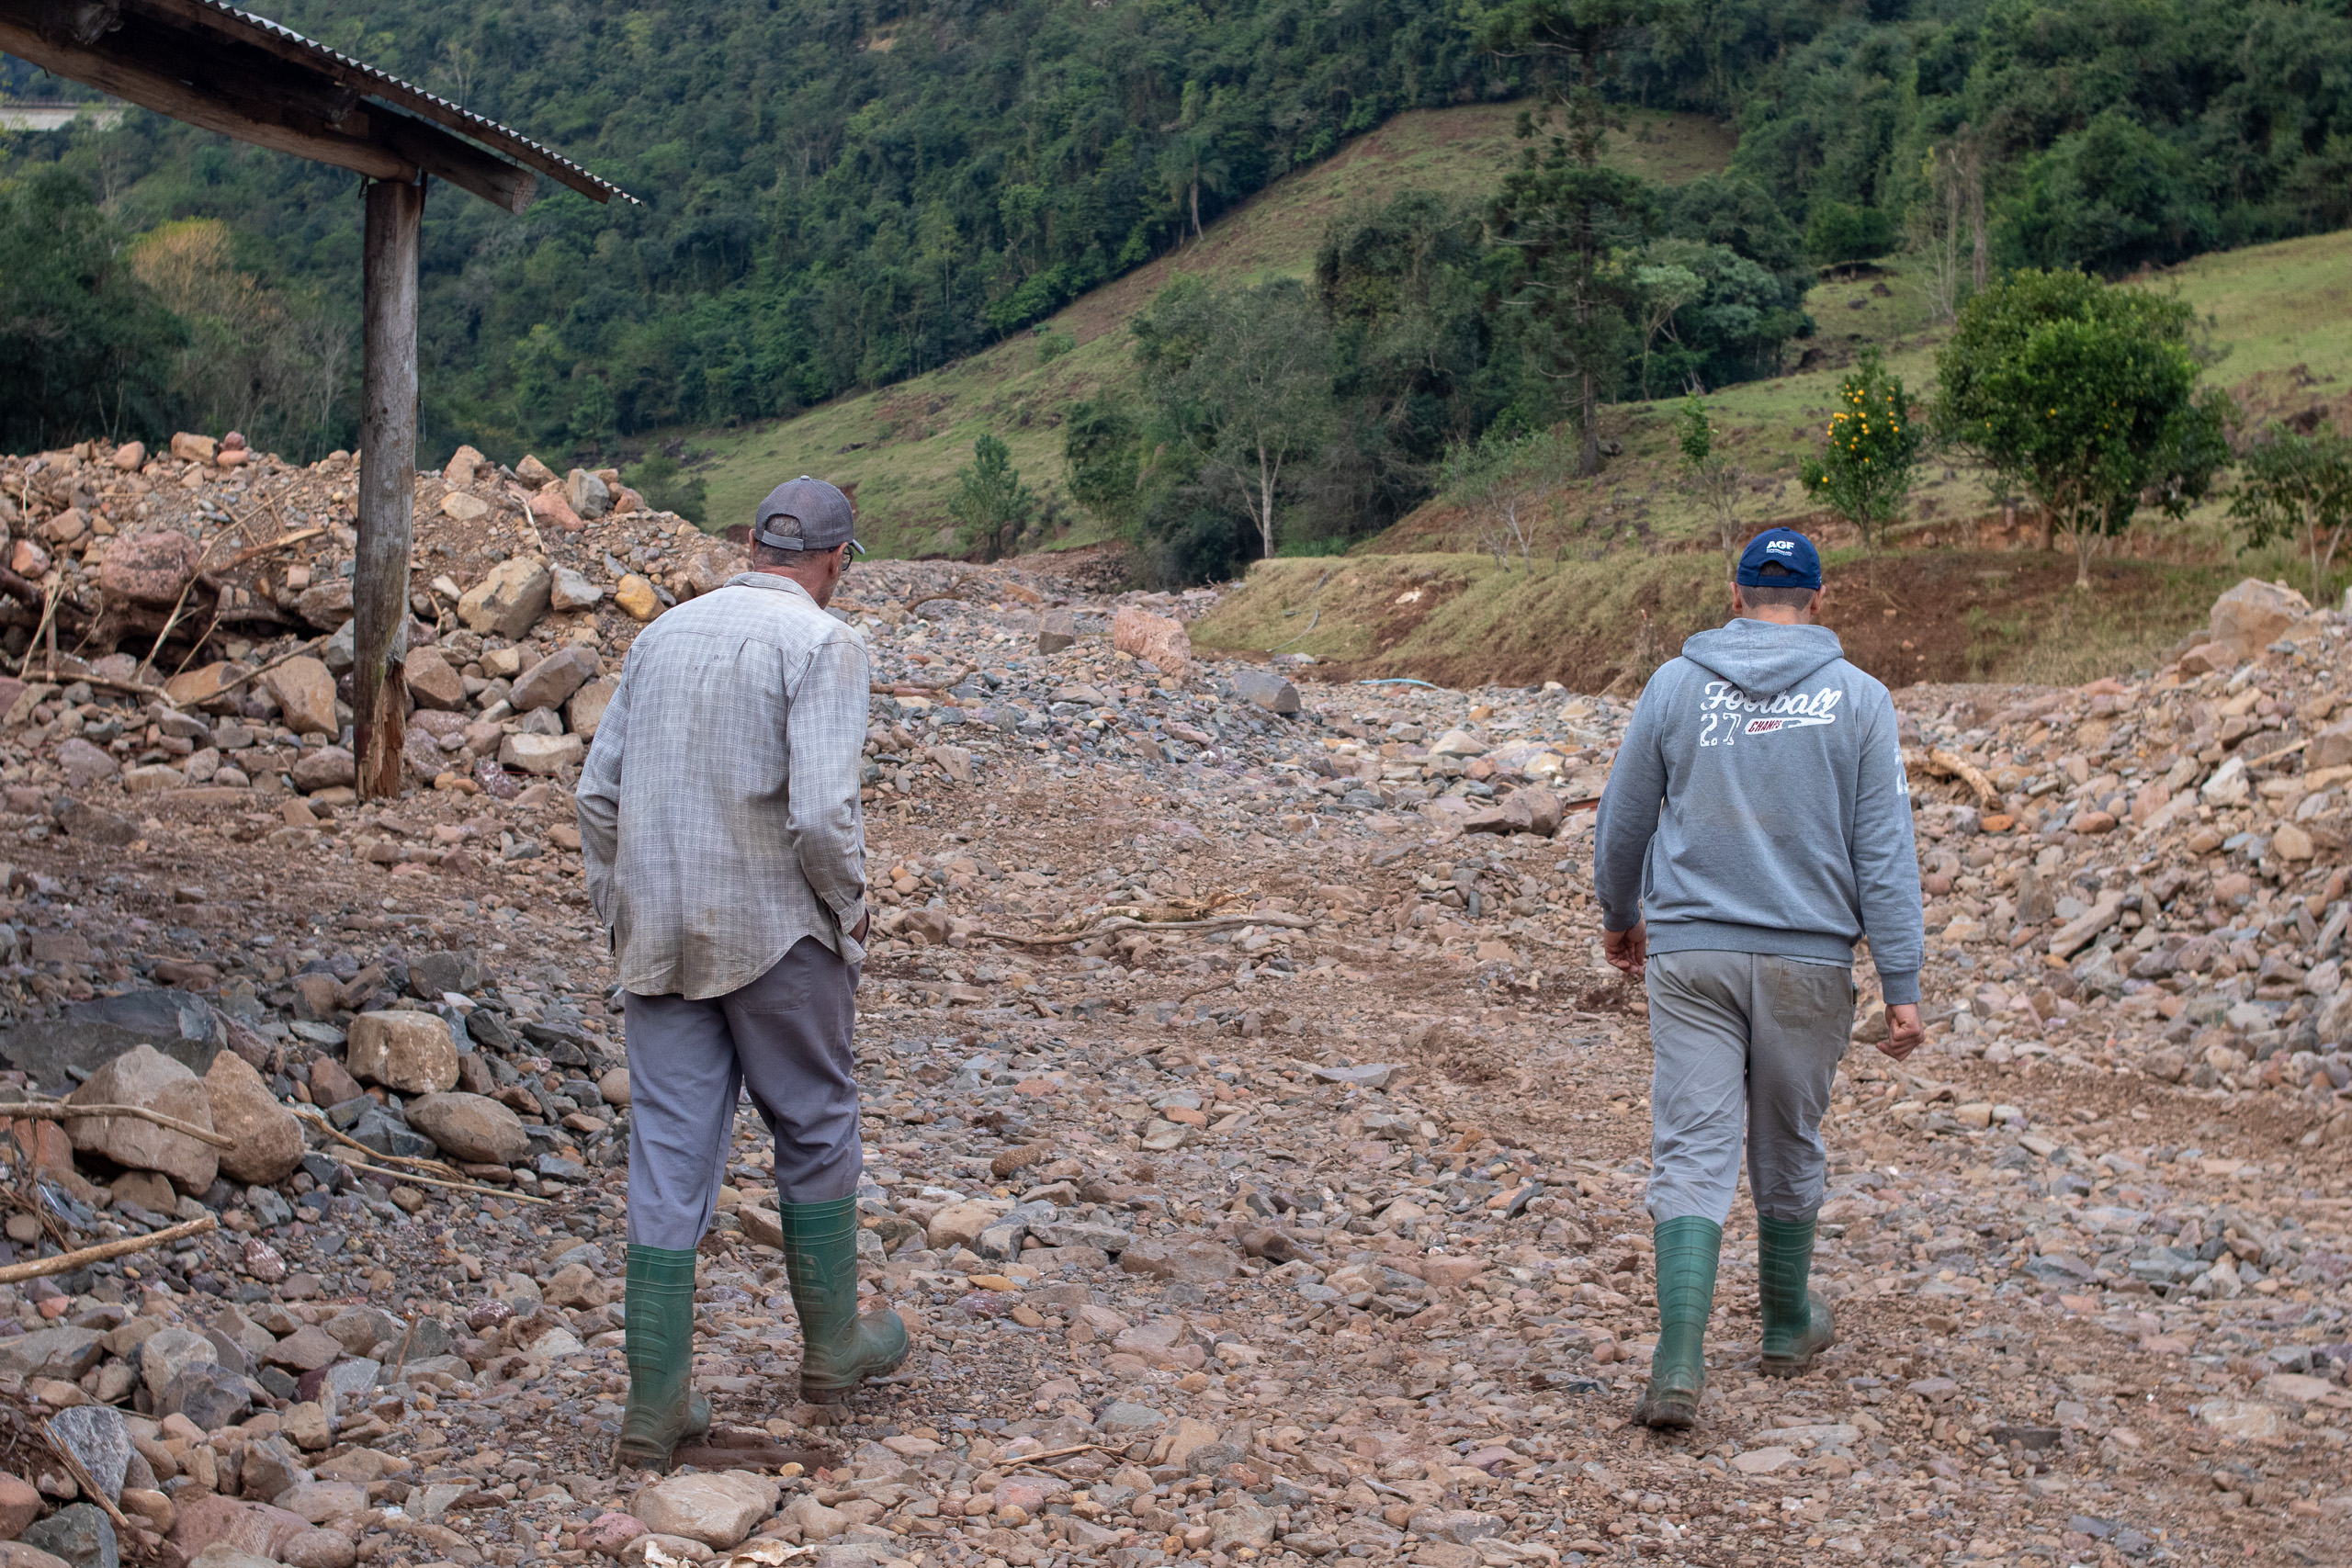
top-left (1193, 232), bottom-right (2352, 689)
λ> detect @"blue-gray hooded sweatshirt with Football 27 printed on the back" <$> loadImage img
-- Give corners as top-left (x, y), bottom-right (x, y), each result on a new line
top-left (1592, 618), bottom-right (1927, 1004)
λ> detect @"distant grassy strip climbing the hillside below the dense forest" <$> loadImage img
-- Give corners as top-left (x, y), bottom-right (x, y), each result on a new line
top-left (694, 104), bottom-right (1731, 555)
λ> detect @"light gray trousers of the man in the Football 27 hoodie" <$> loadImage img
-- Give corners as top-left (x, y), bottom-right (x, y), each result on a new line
top-left (1646, 952), bottom-right (1853, 1224)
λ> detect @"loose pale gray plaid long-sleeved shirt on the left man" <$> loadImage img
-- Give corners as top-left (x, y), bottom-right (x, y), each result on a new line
top-left (579, 571), bottom-right (868, 999)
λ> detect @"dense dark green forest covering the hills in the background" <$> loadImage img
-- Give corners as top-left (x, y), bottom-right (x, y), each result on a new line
top-left (0, 0), bottom-right (2352, 472)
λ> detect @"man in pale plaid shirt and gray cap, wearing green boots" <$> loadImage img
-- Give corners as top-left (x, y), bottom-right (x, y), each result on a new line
top-left (579, 475), bottom-right (908, 1470)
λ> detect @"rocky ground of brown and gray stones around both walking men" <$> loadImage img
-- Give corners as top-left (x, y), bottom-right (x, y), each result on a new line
top-left (0, 437), bottom-right (2352, 1568)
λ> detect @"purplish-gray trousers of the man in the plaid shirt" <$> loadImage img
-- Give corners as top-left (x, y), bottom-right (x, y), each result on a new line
top-left (623, 936), bottom-right (865, 1251)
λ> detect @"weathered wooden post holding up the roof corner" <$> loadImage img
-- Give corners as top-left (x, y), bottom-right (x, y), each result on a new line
top-left (350, 179), bottom-right (425, 799)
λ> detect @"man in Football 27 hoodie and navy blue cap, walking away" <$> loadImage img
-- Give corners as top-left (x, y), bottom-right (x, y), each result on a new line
top-left (1592, 529), bottom-right (1927, 1427)
